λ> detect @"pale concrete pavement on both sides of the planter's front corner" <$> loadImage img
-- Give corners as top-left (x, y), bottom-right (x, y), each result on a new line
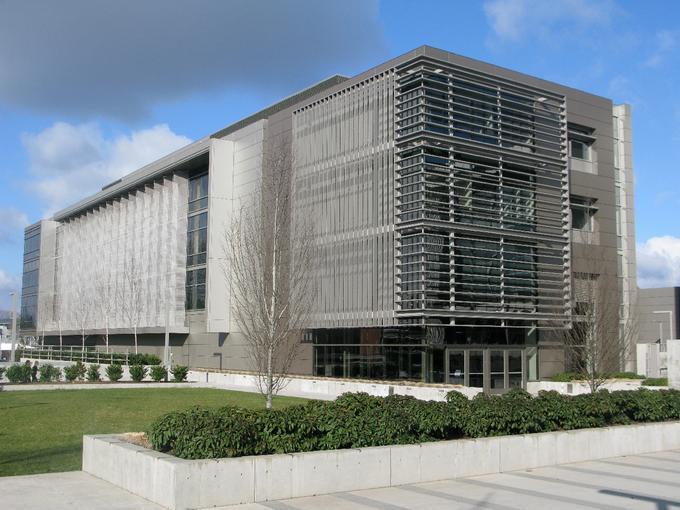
top-left (0, 450), bottom-right (680, 510)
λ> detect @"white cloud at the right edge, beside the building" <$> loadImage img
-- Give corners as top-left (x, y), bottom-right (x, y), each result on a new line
top-left (637, 236), bottom-right (680, 288)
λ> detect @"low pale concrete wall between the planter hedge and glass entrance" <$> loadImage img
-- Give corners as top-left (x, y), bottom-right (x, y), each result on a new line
top-left (187, 370), bottom-right (482, 401)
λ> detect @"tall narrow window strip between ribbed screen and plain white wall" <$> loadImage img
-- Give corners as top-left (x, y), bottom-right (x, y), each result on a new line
top-left (185, 173), bottom-right (208, 310)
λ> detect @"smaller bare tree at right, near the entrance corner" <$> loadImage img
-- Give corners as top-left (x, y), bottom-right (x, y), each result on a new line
top-left (558, 255), bottom-right (637, 393)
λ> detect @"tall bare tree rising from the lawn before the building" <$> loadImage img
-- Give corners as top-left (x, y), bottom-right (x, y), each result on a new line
top-left (224, 139), bottom-right (314, 409)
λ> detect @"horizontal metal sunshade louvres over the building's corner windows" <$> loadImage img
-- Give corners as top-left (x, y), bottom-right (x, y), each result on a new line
top-left (395, 58), bottom-right (570, 327)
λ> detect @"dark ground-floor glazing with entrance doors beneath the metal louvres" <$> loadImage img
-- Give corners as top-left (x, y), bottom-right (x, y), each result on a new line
top-left (311, 327), bottom-right (536, 391)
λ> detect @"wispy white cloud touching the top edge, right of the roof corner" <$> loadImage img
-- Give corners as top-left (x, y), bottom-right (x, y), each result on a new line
top-left (484, 0), bottom-right (614, 41)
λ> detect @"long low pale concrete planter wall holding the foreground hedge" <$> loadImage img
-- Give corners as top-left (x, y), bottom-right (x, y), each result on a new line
top-left (83, 422), bottom-right (680, 509)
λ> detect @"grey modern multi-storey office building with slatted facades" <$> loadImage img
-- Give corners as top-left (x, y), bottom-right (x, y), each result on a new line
top-left (22, 47), bottom-right (637, 391)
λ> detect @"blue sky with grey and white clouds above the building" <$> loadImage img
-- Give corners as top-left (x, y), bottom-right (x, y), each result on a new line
top-left (0, 0), bottom-right (680, 309)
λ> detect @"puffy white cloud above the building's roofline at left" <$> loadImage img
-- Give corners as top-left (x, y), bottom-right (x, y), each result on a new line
top-left (22, 122), bottom-right (191, 215)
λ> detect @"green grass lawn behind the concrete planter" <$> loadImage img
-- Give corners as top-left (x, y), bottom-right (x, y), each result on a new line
top-left (0, 388), bottom-right (304, 476)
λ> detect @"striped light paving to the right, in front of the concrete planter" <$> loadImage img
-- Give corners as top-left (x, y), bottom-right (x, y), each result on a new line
top-left (220, 450), bottom-right (680, 510)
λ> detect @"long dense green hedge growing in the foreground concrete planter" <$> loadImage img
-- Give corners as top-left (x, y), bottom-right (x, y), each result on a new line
top-left (147, 389), bottom-right (680, 459)
